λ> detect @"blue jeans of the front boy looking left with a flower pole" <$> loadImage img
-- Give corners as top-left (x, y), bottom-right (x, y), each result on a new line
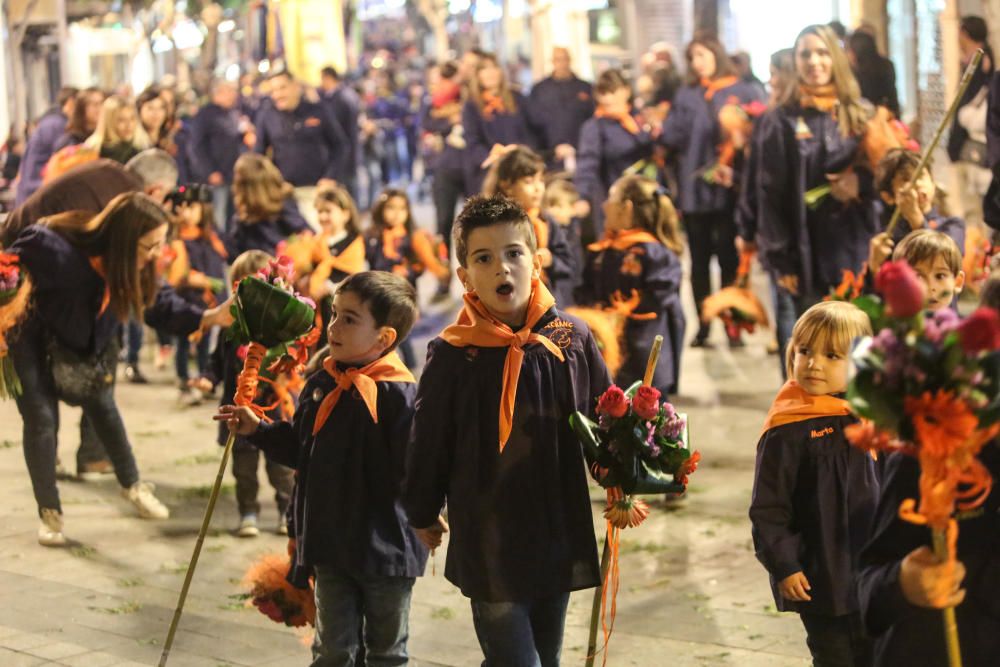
top-left (312, 565), bottom-right (415, 667)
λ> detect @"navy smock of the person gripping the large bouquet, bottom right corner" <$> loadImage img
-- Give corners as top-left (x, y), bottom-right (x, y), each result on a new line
top-left (858, 442), bottom-right (1000, 667)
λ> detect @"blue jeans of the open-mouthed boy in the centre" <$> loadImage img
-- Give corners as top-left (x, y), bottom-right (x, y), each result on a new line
top-left (472, 593), bottom-right (569, 667)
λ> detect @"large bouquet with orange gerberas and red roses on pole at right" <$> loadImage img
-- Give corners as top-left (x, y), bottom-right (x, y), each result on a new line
top-left (847, 262), bottom-right (1000, 667)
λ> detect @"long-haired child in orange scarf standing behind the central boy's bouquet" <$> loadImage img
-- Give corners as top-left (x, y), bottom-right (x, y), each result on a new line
top-left (582, 176), bottom-right (685, 394)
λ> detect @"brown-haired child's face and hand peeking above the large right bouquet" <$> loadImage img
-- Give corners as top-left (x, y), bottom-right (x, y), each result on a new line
top-left (866, 229), bottom-right (965, 311)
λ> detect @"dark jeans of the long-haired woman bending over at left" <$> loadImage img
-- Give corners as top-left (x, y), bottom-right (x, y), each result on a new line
top-left (10, 334), bottom-right (139, 513)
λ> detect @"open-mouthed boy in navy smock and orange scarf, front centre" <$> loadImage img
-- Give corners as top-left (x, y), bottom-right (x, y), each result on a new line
top-left (403, 197), bottom-right (610, 667)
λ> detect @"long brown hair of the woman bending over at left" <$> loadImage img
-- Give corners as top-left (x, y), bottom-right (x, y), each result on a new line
top-left (39, 192), bottom-right (168, 322)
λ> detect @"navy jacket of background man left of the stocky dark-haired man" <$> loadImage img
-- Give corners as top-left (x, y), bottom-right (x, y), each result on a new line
top-left (188, 104), bottom-right (246, 184)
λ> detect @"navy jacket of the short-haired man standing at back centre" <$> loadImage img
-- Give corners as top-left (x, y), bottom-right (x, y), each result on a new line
top-left (529, 75), bottom-right (594, 151)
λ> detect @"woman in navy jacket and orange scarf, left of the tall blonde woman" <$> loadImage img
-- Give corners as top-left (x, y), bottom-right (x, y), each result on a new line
top-left (661, 37), bottom-right (763, 346)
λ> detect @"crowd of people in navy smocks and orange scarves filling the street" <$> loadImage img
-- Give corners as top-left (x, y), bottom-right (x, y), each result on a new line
top-left (0, 17), bottom-right (1000, 666)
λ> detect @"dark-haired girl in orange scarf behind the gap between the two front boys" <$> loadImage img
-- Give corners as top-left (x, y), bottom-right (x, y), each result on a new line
top-left (366, 188), bottom-right (451, 368)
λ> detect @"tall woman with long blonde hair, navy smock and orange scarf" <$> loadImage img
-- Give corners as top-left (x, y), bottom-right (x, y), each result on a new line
top-left (753, 26), bottom-right (877, 372)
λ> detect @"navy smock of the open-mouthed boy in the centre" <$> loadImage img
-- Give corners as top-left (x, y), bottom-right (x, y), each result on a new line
top-left (403, 308), bottom-right (611, 602)
